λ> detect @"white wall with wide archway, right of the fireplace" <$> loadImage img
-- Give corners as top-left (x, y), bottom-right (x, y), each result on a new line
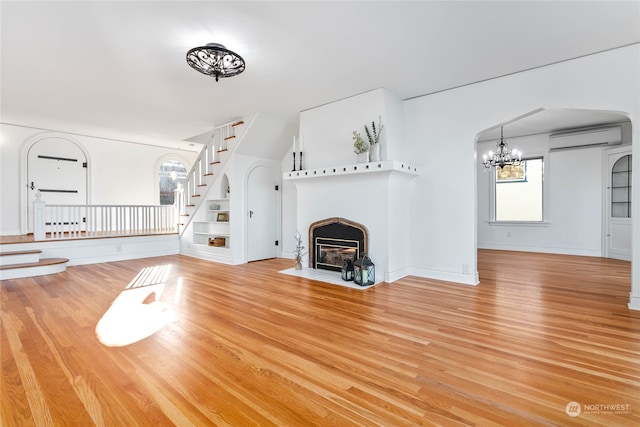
top-left (404, 45), bottom-right (640, 298)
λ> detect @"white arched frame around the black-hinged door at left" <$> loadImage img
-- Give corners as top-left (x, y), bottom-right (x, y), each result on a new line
top-left (18, 132), bottom-right (92, 234)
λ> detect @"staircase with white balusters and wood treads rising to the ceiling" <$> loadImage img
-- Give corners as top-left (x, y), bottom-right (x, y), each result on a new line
top-left (177, 116), bottom-right (249, 234)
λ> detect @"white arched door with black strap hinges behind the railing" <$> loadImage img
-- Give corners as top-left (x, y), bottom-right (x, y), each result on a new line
top-left (26, 137), bottom-right (87, 233)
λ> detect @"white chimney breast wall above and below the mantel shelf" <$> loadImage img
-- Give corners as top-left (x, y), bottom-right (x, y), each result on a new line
top-left (282, 89), bottom-right (413, 281)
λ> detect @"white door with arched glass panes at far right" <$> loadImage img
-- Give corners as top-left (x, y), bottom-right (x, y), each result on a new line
top-left (605, 149), bottom-right (631, 261)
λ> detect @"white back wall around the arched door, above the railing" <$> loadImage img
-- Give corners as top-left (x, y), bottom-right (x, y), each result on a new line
top-left (0, 124), bottom-right (197, 235)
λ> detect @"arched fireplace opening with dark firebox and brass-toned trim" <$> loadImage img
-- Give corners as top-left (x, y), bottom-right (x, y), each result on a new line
top-left (309, 218), bottom-right (369, 271)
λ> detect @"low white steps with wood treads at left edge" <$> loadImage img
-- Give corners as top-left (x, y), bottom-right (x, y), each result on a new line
top-left (0, 250), bottom-right (69, 280)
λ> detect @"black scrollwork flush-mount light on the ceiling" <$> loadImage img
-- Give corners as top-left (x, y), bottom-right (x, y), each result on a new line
top-left (187, 43), bottom-right (244, 81)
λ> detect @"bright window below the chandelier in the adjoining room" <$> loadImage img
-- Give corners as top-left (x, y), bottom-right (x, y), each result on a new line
top-left (495, 158), bottom-right (543, 222)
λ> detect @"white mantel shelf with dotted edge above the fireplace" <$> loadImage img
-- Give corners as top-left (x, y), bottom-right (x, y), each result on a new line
top-left (282, 160), bottom-right (420, 181)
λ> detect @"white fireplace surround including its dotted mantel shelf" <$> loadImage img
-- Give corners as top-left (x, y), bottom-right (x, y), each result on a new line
top-left (283, 160), bottom-right (420, 283)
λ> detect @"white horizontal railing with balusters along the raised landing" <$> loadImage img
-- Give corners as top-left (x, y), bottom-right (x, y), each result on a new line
top-left (33, 194), bottom-right (178, 241)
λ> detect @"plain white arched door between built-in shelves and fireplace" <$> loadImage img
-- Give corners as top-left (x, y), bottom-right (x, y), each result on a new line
top-left (247, 166), bottom-right (278, 262)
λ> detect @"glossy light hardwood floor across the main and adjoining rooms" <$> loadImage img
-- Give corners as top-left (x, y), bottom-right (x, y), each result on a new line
top-left (0, 250), bottom-right (640, 426)
